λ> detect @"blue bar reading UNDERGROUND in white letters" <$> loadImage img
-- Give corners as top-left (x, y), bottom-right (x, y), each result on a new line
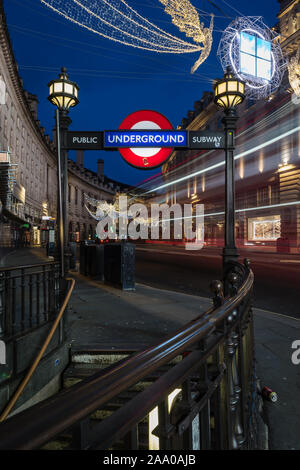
top-left (104, 130), bottom-right (187, 148)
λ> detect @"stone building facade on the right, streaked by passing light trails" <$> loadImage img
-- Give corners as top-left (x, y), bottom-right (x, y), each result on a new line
top-left (163, 0), bottom-right (300, 253)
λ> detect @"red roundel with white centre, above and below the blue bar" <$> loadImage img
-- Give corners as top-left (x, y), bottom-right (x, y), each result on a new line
top-left (119, 110), bottom-right (173, 170)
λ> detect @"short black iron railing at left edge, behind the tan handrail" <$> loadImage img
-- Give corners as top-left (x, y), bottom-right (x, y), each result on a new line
top-left (0, 262), bottom-right (60, 338)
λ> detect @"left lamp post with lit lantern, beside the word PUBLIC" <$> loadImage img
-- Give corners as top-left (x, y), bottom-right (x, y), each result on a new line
top-left (48, 67), bottom-right (79, 277)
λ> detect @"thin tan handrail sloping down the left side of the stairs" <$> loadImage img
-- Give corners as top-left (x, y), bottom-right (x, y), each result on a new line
top-left (0, 278), bottom-right (75, 422)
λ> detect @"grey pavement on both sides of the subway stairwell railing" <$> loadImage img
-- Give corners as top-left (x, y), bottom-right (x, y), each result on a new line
top-left (2, 248), bottom-right (300, 450)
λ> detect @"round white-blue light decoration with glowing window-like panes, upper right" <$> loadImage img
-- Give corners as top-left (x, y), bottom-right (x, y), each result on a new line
top-left (217, 16), bottom-right (286, 99)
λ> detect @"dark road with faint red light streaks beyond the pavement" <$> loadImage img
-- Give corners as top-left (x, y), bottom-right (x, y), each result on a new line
top-left (136, 245), bottom-right (300, 318)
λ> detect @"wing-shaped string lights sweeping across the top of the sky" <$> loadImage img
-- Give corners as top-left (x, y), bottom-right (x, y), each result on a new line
top-left (41, 0), bottom-right (213, 73)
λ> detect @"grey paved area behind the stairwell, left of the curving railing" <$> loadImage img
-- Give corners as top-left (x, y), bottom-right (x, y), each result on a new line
top-left (69, 273), bottom-right (212, 347)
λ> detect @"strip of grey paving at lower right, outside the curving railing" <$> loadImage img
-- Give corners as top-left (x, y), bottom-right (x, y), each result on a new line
top-left (254, 309), bottom-right (300, 450)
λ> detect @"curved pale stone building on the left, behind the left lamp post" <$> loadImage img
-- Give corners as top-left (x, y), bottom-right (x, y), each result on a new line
top-left (0, 1), bottom-right (124, 247)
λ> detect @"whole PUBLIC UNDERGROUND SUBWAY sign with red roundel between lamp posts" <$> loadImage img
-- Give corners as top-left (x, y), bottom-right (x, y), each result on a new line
top-left (65, 110), bottom-right (226, 170)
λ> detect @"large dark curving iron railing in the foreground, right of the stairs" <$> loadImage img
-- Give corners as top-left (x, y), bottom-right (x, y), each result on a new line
top-left (0, 260), bottom-right (257, 450)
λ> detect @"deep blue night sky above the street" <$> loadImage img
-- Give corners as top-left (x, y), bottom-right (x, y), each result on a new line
top-left (4, 0), bottom-right (279, 184)
